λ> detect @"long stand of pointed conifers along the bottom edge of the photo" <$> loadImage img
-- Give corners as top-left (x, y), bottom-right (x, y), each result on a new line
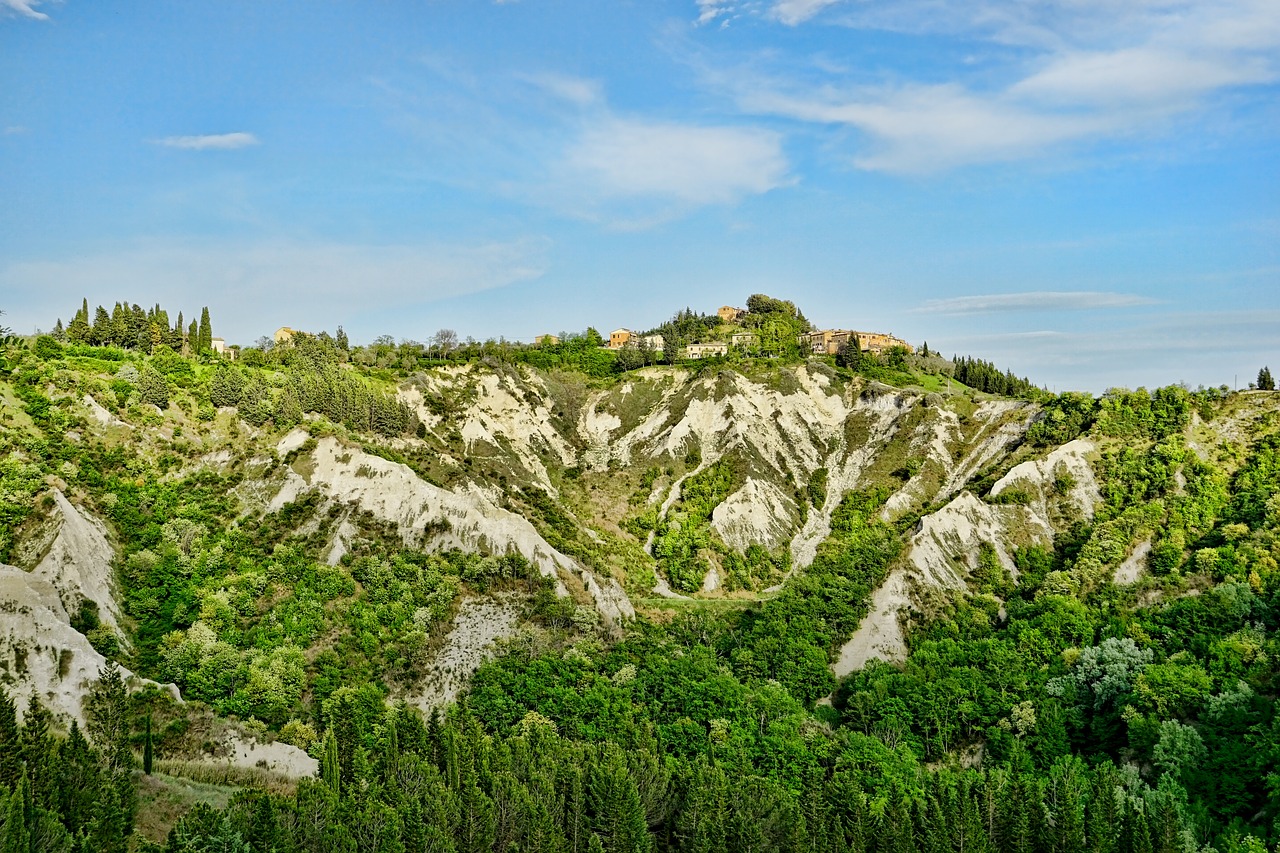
top-left (154, 697), bottom-right (1223, 853)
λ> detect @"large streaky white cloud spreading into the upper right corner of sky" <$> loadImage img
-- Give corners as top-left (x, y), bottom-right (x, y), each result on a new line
top-left (717, 0), bottom-right (1280, 173)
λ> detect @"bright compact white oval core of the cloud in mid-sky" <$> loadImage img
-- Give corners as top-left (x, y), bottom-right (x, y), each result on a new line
top-left (567, 118), bottom-right (787, 205)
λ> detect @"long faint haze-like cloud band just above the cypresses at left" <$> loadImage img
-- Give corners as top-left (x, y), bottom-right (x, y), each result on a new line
top-left (0, 240), bottom-right (548, 343)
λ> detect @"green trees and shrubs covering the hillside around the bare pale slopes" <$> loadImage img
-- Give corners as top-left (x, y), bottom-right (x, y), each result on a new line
top-left (0, 301), bottom-right (1280, 853)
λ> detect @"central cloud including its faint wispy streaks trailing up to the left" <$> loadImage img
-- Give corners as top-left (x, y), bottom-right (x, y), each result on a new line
top-left (378, 61), bottom-right (792, 224)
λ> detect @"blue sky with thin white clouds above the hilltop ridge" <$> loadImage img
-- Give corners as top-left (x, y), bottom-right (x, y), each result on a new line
top-left (0, 0), bottom-right (1280, 393)
